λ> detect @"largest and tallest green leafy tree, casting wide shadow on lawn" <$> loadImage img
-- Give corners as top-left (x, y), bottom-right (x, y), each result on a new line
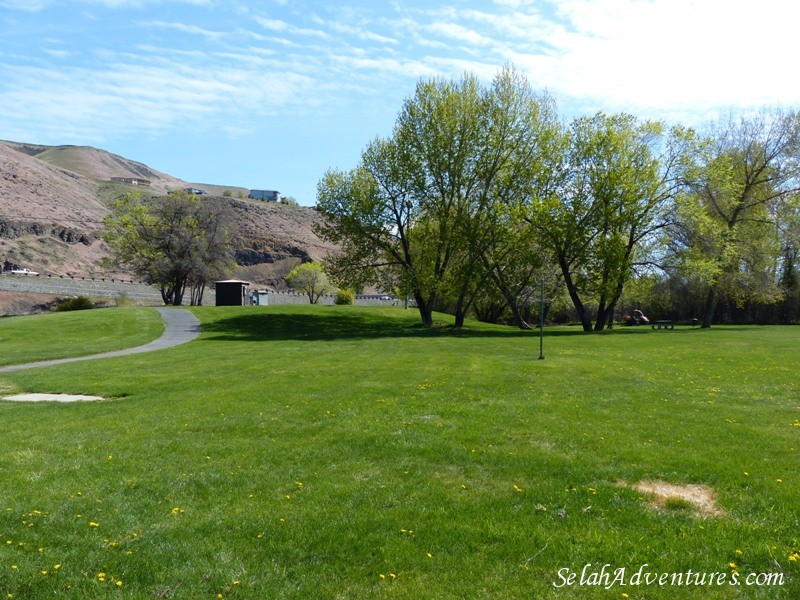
top-left (317, 69), bottom-right (560, 326)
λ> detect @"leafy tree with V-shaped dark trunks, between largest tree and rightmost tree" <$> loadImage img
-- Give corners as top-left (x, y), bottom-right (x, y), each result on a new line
top-left (527, 113), bottom-right (686, 331)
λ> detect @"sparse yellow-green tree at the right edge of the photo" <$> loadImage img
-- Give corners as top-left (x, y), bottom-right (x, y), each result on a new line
top-left (674, 110), bottom-right (800, 327)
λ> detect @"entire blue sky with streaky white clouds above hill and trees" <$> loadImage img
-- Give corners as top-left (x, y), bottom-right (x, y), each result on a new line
top-left (0, 0), bottom-right (800, 205)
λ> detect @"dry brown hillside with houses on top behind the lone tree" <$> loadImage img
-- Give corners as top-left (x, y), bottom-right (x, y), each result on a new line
top-left (0, 141), bottom-right (333, 284)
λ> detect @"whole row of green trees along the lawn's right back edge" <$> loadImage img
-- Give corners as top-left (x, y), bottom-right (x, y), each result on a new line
top-left (317, 68), bottom-right (800, 331)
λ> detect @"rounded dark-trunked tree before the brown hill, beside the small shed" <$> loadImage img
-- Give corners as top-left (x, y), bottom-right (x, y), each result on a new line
top-left (103, 192), bottom-right (233, 305)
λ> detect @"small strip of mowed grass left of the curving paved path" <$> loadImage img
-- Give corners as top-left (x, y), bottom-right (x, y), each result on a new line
top-left (0, 308), bottom-right (164, 366)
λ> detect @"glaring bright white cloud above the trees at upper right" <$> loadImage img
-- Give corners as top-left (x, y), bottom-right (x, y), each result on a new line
top-left (515, 0), bottom-right (800, 119)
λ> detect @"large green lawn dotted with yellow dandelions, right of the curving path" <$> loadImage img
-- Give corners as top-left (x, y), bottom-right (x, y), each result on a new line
top-left (0, 306), bottom-right (800, 599)
